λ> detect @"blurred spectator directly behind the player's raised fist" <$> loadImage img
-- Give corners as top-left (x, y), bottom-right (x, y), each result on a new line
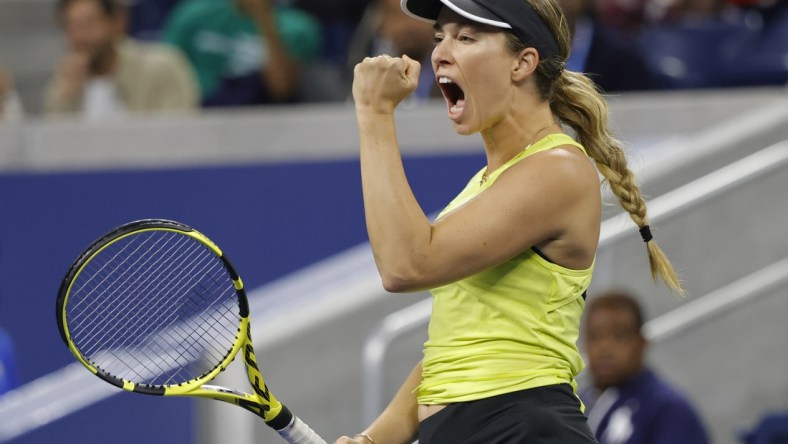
top-left (348, 0), bottom-right (442, 101)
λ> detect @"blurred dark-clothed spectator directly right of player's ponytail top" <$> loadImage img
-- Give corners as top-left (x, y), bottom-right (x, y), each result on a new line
top-left (557, 0), bottom-right (660, 92)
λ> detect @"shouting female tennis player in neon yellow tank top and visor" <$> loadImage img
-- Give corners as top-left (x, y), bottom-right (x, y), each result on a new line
top-left (336, 0), bottom-right (682, 444)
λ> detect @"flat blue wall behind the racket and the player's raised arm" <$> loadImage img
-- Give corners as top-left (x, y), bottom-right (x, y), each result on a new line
top-left (0, 154), bottom-right (484, 444)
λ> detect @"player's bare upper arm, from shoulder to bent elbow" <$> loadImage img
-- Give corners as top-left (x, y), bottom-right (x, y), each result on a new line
top-left (412, 153), bottom-right (587, 286)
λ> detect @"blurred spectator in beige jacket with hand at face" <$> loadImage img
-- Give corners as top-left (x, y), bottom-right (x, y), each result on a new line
top-left (45, 0), bottom-right (198, 120)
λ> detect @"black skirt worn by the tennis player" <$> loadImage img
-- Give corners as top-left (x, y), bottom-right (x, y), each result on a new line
top-left (419, 384), bottom-right (597, 444)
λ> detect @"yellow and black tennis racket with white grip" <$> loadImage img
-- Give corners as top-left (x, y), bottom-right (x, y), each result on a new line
top-left (57, 219), bottom-right (325, 444)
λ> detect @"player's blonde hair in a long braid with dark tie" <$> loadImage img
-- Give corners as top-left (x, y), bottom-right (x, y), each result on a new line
top-left (507, 0), bottom-right (685, 295)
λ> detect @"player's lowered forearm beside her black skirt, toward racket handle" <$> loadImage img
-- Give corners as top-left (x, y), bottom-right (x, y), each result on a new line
top-left (362, 362), bottom-right (421, 444)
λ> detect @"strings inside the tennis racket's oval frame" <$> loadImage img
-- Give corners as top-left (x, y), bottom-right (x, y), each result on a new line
top-left (66, 231), bottom-right (239, 385)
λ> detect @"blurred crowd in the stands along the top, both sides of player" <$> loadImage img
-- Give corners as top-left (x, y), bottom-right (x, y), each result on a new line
top-left (0, 0), bottom-right (788, 121)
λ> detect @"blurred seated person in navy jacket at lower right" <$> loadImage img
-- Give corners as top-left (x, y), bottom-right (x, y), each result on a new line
top-left (580, 293), bottom-right (709, 444)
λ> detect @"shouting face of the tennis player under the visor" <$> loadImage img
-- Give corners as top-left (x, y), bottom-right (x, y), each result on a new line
top-left (432, 7), bottom-right (517, 134)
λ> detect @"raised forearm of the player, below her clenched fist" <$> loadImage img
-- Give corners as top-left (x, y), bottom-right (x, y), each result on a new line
top-left (357, 109), bottom-right (431, 291)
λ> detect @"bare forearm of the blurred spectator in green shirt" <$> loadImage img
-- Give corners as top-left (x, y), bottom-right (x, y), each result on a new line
top-left (254, 11), bottom-right (300, 101)
